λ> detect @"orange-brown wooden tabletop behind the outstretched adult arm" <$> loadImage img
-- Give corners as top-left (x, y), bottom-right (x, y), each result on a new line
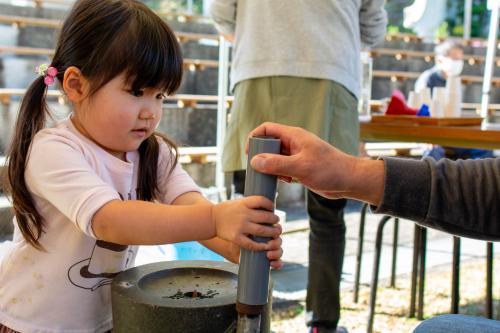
top-left (360, 116), bottom-right (500, 149)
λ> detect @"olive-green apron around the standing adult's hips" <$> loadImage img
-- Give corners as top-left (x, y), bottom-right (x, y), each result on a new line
top-left (222, 76), bottom-right (359, 172)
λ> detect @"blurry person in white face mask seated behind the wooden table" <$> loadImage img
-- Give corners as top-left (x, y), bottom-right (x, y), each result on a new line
top-left (415, 40), bottom-right (493, 160)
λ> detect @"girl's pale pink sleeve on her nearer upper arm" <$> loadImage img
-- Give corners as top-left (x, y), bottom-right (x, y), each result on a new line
top-left (25, 130), bottom-right (120, 237)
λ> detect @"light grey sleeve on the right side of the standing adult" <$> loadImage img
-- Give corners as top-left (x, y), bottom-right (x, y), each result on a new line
top-left (359, 0), bottom-right (387, 46)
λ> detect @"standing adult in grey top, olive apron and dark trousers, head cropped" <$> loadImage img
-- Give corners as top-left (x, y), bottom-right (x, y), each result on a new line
top-left (211, 0), bottom-right (386, 332)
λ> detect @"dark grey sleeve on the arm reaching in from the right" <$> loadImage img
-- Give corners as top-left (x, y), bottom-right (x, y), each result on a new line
top-left (372, 158), bottom-right (500, 240)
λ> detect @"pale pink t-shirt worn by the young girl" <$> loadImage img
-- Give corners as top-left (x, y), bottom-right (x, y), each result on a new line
top-left (0, 119), bottom-right (199, 333)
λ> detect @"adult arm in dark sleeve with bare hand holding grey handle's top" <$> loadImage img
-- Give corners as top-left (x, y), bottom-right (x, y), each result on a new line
top-left (250, 123), bottom-right (500, 240)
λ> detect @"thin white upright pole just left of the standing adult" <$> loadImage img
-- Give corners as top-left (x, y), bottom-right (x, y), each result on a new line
top-left (215, 36), bottom-right (229, 200)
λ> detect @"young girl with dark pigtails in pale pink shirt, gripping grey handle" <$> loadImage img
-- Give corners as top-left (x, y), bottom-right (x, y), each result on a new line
top-left (0, 0), bottom-right (281, 333)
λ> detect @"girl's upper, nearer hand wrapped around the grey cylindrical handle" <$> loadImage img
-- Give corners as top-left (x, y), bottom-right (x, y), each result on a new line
top-left (212, 196), bottom-right (281, 250)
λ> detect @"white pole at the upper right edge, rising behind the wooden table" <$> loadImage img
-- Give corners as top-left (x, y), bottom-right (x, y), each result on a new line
top-left (481, 0), bottom-right (499, 119)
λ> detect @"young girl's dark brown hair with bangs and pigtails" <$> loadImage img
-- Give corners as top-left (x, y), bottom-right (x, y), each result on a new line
top-left (8, 0), bottom-right (182, 249)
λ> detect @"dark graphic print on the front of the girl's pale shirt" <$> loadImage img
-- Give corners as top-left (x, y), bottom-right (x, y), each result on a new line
top-left (68, 193), bottom-right (134, 291)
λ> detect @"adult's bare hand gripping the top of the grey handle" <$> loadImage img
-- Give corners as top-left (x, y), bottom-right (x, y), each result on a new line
top-left (250, 123), bottom-right (384, 204)
